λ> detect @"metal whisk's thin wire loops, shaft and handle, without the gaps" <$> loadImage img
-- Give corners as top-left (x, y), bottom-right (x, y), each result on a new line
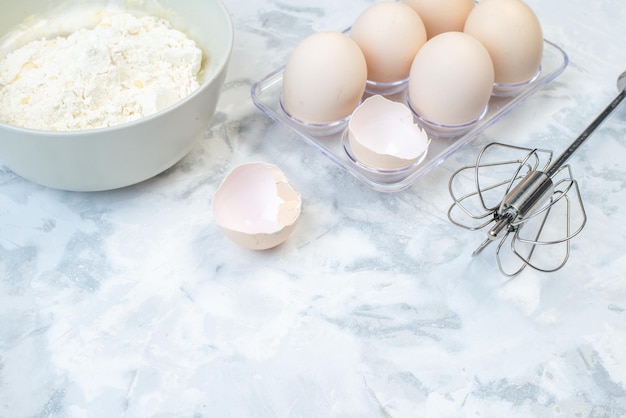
top-left (448, 71), bottom-right (626, 276)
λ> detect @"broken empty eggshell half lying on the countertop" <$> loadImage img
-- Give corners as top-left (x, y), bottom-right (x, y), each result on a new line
top-left (212, 162), bottom-right (302, 250)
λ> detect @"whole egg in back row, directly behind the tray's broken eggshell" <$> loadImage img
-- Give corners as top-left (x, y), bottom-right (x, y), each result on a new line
top-left (350, 1), bottom-right (426, 83)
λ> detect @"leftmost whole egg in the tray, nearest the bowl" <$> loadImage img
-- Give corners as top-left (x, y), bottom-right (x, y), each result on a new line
top-left (282, 31), bottom-right (367, 124)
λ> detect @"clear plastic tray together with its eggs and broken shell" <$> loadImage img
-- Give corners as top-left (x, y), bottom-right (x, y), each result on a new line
top-left (214, 0), bottom-right (568, 251)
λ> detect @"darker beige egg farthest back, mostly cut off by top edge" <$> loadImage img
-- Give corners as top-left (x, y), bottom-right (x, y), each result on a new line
top-left (403, 0), bottom-right (474, 39)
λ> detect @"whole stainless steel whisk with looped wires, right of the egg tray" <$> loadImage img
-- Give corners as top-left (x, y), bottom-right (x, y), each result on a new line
top-left (448, 71), bottom-right (626, 276)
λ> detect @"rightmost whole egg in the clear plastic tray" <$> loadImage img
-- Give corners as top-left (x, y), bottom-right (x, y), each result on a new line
top-left (464, 0), bottom-right (543, 85)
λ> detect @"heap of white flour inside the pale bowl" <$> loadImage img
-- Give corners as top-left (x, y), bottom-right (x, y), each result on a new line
top-left (0, 12), bottom-right (203, 131)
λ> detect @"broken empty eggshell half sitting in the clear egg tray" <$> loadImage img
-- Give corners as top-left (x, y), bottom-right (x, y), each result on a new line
top-left (348, 95), bottom-right (430, 170)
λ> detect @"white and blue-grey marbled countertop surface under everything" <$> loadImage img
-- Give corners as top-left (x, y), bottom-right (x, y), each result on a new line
top-left (0, 0), bottom-right (626, 418)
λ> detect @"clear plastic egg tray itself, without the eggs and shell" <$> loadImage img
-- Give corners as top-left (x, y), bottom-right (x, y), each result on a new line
top-left (251, 40), bottom-right (569, 192)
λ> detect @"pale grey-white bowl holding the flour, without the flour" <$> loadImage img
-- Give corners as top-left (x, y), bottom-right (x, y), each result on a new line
top-left (0, 0), bottom-right (233, 191)
